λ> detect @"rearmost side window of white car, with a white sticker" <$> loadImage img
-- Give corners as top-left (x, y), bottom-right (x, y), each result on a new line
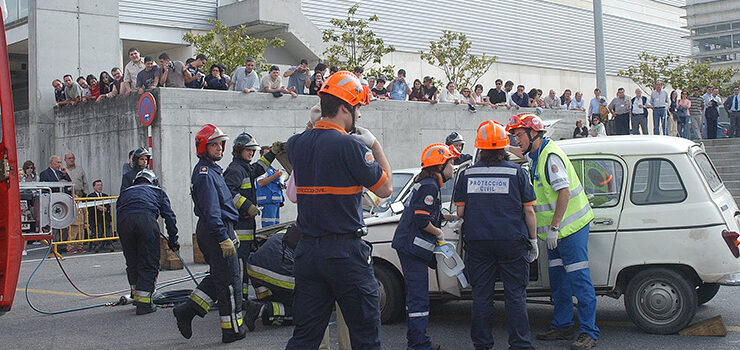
top-left (630, 159), bottom-right (686, 205)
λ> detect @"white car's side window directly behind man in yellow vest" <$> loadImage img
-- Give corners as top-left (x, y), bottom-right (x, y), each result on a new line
top-left (572, 159), bottom-right (624, 208)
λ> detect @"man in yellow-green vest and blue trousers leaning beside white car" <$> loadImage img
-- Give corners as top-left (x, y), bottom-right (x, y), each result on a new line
top-left (506, 113), bottom-right (599, 349)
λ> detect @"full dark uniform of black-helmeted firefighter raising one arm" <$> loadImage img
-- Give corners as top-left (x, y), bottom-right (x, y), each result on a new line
top-left (224, 152), bottom-right (275, 297)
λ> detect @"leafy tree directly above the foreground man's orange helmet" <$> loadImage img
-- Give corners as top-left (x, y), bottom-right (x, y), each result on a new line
top-left (322, 4), bottom-right (396, 75)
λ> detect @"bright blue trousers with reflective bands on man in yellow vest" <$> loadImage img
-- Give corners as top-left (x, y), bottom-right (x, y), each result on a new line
top-left (547, 225), bottom-right (599, 339)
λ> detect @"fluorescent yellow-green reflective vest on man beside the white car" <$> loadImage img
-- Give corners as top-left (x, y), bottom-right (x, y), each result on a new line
top-left (532, 139), bottom-right (594, 239)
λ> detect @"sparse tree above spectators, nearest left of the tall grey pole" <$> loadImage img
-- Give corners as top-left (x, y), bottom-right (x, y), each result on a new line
top-left (419, 30), bottom-right (496, 88)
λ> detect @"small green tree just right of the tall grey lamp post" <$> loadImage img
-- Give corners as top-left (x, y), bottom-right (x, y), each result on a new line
top-left (617, 51), bottom-right (679, 94)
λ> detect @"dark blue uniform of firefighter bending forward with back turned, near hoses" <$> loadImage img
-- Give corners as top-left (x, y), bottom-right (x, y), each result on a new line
top-left (116, 184), bottom-right (177, 305)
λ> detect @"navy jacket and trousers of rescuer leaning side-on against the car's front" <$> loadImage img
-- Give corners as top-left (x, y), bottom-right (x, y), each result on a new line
top-left (391, 178), bottom-right (442, 350)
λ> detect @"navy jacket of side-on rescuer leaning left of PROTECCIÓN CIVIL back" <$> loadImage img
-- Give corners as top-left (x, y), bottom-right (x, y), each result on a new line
top-left (391, 178), bottom-right (442, 262)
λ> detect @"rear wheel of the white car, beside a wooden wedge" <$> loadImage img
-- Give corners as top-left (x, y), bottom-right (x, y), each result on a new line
top-left (624, 268), bottom-right (697, 334)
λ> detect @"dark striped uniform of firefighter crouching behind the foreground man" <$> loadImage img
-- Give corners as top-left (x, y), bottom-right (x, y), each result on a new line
top-left (247, 230), bottom-right (295, 326)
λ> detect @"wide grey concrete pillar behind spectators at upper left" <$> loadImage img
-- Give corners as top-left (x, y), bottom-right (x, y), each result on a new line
top-left (28, 0), bottom-right (121, 164)
